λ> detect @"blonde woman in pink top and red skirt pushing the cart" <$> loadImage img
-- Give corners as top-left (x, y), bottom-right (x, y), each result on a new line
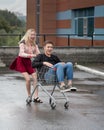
top-left (10, 29), bottom-right (42, 103)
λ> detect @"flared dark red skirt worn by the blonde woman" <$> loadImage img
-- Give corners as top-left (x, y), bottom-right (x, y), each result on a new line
top-left (10, 56), bottom-right (36, 74)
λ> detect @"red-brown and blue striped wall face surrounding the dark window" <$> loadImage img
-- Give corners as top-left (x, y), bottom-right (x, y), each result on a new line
top-left (56, 0), bottom-right (104, 46)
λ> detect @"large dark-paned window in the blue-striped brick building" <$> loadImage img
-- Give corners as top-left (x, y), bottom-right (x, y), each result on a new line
top-left (74, 7), bottom-right (94, 36)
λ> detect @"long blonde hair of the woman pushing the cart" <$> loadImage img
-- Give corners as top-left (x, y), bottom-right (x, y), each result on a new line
top-left (19, 28), bottom-right (36, 45)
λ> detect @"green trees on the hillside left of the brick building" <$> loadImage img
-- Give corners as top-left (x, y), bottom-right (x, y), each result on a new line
top-left (0, 10), bottom-right (25, 46)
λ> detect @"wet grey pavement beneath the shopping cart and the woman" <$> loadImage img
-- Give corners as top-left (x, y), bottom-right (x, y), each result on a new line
top-left (0, 67), bottom-right (104, 130)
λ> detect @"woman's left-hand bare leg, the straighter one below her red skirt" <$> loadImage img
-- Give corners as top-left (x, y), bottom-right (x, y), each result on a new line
top-left (22, 72), bottom-right (31, 96)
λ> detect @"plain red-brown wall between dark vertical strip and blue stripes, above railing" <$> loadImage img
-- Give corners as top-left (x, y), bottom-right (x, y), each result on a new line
top-left (40, 0), bottom-right (56, 33)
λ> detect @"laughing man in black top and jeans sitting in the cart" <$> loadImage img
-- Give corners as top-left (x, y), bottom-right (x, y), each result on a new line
top-left (32, 41), bottom-right (76, 92)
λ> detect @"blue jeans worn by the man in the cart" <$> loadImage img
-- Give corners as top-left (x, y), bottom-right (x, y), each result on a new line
top-left (44, 62), bottom-right (73, 82)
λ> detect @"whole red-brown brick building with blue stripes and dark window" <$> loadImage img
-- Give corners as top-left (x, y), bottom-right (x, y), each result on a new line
top-left (27, 0), bottom-right (104, 46)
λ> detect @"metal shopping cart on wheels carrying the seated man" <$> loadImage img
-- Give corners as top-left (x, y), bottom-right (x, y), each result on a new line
top-left (26, 66), bottom-right (69, 109)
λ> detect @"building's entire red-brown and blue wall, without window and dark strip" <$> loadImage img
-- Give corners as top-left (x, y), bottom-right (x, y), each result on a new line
top-left (27, 0), bottom-right (104, 46)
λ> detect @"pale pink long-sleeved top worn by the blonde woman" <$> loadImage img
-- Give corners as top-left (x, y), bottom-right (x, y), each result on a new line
top-left (19, 43), bottom-right (40, 58)
